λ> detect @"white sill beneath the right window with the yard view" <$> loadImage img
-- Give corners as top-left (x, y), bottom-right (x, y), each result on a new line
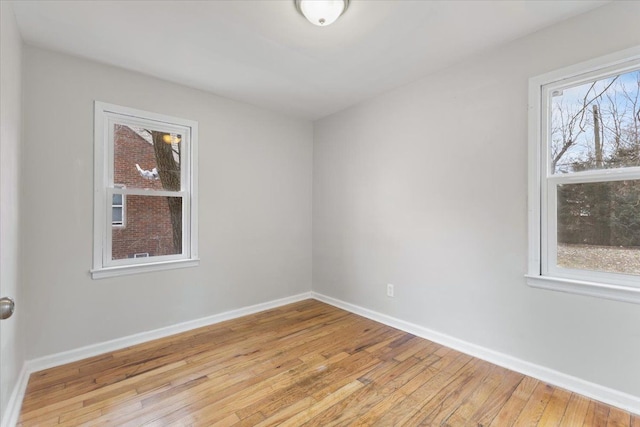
top-left (525, 274), bottom-right (640, 304)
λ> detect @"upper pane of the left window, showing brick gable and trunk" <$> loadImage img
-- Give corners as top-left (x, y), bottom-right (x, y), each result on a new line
top-left (113, 124), bottom-right (182, 191)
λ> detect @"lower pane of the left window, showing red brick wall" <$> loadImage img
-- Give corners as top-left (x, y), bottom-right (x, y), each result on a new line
top-left (111, 195), bottom-right (182, 260)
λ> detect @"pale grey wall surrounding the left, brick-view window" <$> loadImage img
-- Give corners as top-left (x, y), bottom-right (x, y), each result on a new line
top-left (22, 47), bottom-right (313, 359)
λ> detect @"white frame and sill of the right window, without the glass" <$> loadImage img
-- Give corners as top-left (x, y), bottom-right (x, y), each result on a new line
top-left (525, 46), bottom-right (640, 303)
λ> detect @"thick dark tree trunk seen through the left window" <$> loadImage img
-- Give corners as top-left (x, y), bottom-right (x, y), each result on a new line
top-left (151, 131), bottom-right (182, 253)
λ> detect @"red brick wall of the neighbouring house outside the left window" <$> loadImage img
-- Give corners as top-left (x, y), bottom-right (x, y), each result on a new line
top-left (112, 125), bottom-right (175, 259)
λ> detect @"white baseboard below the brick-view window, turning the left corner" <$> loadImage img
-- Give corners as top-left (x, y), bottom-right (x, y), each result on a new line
top-left (0, 292), bottom-right (312, 427)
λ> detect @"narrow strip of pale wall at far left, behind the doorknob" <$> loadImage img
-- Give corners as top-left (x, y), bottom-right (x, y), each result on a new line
top-left (0, 1), bottom-right (25, 418)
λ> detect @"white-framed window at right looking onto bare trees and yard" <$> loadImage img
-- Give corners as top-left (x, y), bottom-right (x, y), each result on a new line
top-left (527, 48), bottom-right (640, 302)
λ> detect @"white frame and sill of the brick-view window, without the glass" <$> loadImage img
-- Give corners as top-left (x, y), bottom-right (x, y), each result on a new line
top-left (90, 101), bottom-right (199, 279)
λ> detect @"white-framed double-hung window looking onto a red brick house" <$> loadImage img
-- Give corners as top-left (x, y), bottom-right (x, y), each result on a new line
top-left (91, 102), bottom-right (198, 279)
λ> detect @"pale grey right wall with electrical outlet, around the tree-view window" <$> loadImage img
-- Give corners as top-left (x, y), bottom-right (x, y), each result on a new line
top-left (313, 2), bottom-right (640, 396)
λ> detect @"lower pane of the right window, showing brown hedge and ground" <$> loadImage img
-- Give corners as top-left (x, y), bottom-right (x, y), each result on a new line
top-left (557, 180), bottom-right (640, 274)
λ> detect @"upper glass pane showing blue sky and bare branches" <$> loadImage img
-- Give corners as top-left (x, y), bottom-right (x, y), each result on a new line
top-left (549, 70), bottom-right (640, 173)
